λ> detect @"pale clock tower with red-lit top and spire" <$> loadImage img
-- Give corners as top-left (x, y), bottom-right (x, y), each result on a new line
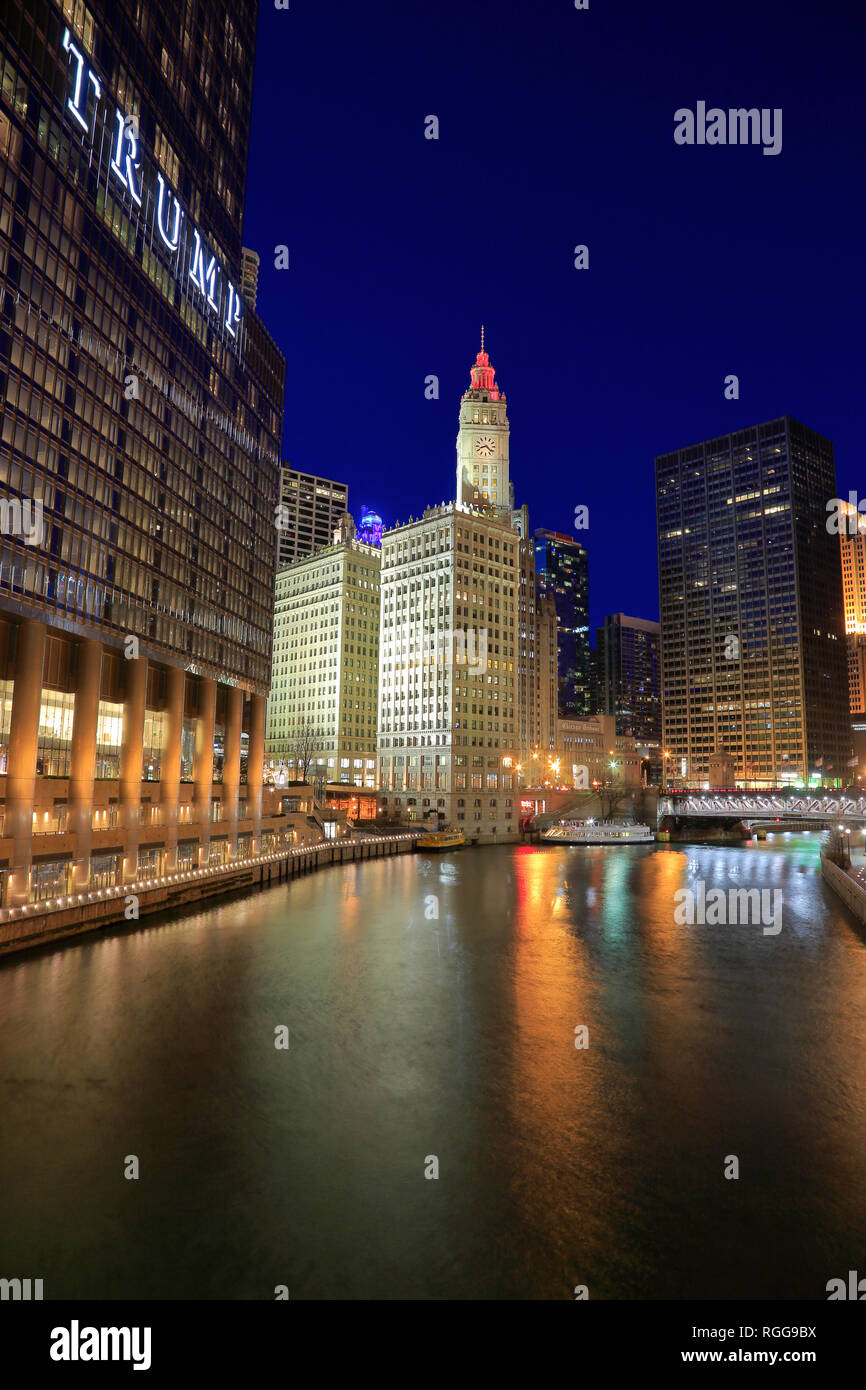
top-left (457, 327), bottom-right (513, 512)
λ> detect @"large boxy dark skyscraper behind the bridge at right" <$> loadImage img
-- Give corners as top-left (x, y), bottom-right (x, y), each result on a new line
top-left (656, 416), bottom-right (851, 787)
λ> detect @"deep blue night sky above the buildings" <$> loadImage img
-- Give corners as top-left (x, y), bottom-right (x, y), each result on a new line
top-left (245, 0), bottom-right (866, 626)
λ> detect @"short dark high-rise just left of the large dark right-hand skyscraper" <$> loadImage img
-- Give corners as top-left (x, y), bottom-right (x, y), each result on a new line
top-left (595, 613), bottom-right (662, 741)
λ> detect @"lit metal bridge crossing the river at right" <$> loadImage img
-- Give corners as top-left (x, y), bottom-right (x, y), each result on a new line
top-left (659, 791), bottom-right (866, 826)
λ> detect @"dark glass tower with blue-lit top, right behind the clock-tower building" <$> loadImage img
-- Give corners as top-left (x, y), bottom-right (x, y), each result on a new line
top-left (535, 531), bottom-right (591, 719)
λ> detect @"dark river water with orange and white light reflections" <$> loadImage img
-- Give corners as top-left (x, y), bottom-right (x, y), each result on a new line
top-left (0, 837), bottom-right (866, 1300)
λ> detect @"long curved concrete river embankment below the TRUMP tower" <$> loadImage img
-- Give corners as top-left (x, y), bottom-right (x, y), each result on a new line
top-left (0, 833), bottom-right (418, 960)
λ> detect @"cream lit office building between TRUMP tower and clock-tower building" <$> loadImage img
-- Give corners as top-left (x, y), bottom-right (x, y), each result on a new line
top-left (265, 516), bottom-right (382, 788)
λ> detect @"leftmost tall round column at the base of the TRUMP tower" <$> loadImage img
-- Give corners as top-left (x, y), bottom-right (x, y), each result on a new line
top-left (6, 619), bottom-right (46, 908)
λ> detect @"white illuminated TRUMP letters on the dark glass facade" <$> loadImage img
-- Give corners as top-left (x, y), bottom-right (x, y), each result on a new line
top-left (63, 29), bottom-right (242, 338)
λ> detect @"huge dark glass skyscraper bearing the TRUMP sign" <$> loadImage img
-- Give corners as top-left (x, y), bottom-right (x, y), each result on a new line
top-left (0, 0), bottom-right (285, 917)
